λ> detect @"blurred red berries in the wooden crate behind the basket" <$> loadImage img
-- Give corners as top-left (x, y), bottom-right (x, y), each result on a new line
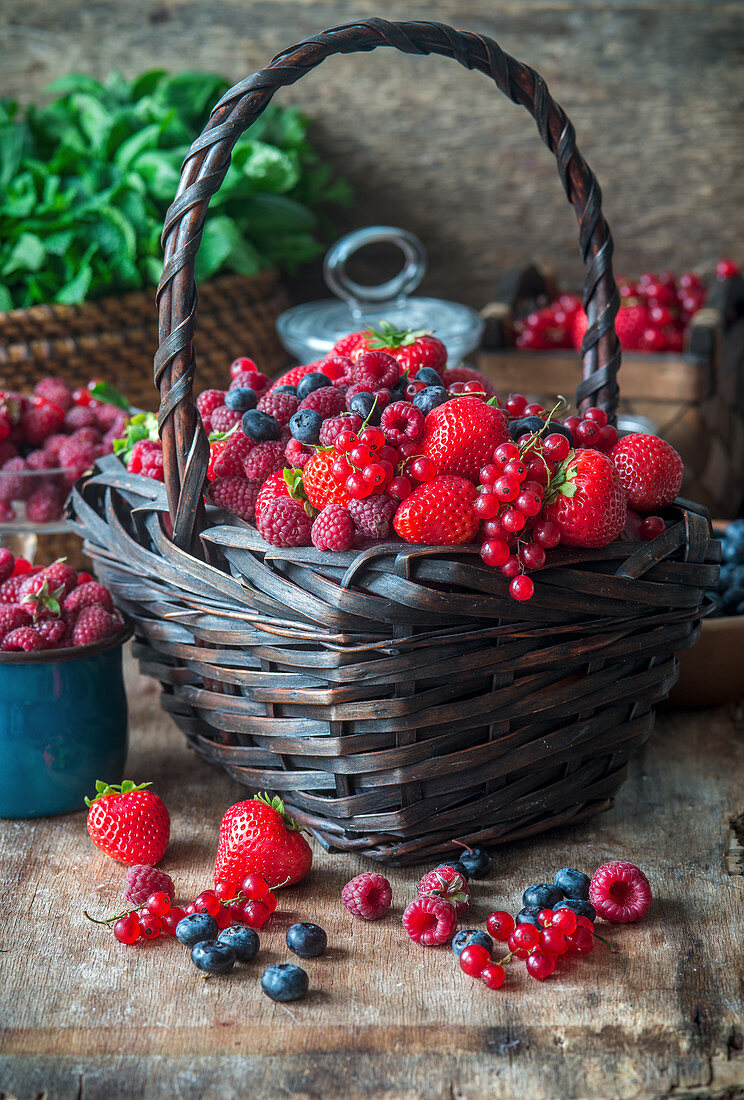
top-left (514, 260), bottom-right (740, 352)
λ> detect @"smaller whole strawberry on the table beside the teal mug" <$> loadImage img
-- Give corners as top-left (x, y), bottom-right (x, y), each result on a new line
top-left (85, 779), bottom-right (171, 865)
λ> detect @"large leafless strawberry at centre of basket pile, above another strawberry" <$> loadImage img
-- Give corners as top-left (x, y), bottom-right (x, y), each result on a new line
top-left (422, 397), bottom-right (510, 482)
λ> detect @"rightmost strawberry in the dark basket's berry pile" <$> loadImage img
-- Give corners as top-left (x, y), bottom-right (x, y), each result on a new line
top-left (609, 433), bottom-right (685, 512)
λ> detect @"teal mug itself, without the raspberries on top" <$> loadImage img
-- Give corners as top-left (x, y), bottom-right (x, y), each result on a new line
top-left (0, 623), bottom-right (132, 817)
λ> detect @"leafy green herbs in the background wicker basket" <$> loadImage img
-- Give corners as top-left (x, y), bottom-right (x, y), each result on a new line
top-left (0, 69), bottom-right (350, 310)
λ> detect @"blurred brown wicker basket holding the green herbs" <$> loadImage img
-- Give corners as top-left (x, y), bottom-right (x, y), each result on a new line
top-left (0, 272), bottom-right (288, 409)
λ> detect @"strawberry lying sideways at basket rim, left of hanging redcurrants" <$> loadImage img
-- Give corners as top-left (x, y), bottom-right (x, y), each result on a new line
top-left (393, 475), bottom-right (480, 546)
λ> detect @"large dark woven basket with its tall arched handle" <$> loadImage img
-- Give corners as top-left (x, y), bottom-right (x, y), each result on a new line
top-left (74, 12), bottom-right (718, 864)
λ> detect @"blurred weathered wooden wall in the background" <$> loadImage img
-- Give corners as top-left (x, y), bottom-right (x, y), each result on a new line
top-left (0, 0), bottom-right (744, 306)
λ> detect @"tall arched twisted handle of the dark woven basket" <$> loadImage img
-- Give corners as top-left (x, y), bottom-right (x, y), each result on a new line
top-left (155, 19), bottom-right (620, 552)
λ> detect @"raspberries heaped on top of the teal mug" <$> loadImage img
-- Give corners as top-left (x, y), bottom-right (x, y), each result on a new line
top-left (0, 548), bottom-right (123, 653)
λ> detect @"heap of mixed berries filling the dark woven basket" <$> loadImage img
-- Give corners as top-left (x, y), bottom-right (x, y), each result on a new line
top-left (122, 326), bottom-right (682, 600)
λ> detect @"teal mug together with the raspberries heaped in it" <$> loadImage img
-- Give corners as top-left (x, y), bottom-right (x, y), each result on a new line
top-left (0, 549), bottom-right (132, 817)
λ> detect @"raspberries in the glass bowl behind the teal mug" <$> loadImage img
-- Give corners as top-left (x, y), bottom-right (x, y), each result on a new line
top-left (0, 377), bottom-right (127, 524)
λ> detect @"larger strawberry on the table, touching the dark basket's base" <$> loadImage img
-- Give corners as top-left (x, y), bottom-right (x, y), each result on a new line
top-left (215, 794), bottom-right (313, 890)
